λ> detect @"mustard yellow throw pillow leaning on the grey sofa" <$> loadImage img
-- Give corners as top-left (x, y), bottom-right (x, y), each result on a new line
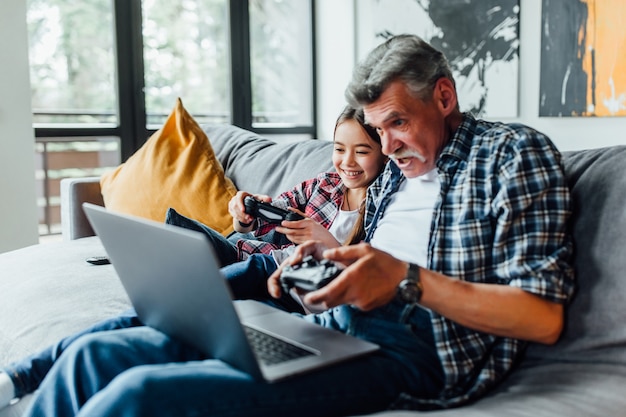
top-left (100, 98), bottom-right (237, 235)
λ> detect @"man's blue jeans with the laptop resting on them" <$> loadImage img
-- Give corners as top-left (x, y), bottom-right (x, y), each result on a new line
top-left (25, 301), bottom-right (443, 417)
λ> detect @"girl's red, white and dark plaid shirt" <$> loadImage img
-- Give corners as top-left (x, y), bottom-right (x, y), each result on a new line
top-left (237, 172), bottom-right (346, 259)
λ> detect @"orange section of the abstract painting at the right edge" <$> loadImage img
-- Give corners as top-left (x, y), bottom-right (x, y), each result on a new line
top-left (579, 0), bottom-right (626, 116)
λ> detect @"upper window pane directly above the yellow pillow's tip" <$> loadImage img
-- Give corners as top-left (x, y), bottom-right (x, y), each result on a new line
top-left (142, 0), bottom-right (231, 128)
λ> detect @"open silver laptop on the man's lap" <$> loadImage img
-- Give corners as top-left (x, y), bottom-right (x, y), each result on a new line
top-left (83, 203), bottom-right (378, 382)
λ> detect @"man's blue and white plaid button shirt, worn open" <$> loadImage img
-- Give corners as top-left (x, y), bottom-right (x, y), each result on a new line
top-left (365, 115), bottom-right (575, 408)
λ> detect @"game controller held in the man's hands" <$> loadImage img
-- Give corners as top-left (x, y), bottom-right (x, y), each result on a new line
top-left (280, 256), bottom-right (341, 292)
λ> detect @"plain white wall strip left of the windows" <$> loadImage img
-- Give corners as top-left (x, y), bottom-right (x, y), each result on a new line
top-left (0, 0), bottom-right (38, 253)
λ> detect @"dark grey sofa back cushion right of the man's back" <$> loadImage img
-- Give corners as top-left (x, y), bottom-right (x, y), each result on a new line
top-left (527, 146), bottom-right (626, 363)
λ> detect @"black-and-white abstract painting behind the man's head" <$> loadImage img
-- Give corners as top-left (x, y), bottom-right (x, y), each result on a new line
top-left (355, 0), bottom-right (519, 117)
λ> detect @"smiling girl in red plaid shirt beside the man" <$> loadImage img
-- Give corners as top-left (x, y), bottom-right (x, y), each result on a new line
top-left (222, 107), bottom-right (387, 313)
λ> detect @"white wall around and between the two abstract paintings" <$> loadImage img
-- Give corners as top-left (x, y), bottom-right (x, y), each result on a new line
top-left (316, 0), bottom-right (626, 151)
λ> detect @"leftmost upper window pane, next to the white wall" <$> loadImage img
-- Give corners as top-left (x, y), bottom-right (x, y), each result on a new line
top-left (28, 0), bottom-right (119, 127)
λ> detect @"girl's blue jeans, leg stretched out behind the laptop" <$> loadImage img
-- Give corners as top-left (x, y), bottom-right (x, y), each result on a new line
top-left (3, 254), bottom-right (302, 397)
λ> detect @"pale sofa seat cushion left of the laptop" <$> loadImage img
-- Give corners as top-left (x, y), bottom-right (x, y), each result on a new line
top-left (0, 236), bottom-right (130, 366)
